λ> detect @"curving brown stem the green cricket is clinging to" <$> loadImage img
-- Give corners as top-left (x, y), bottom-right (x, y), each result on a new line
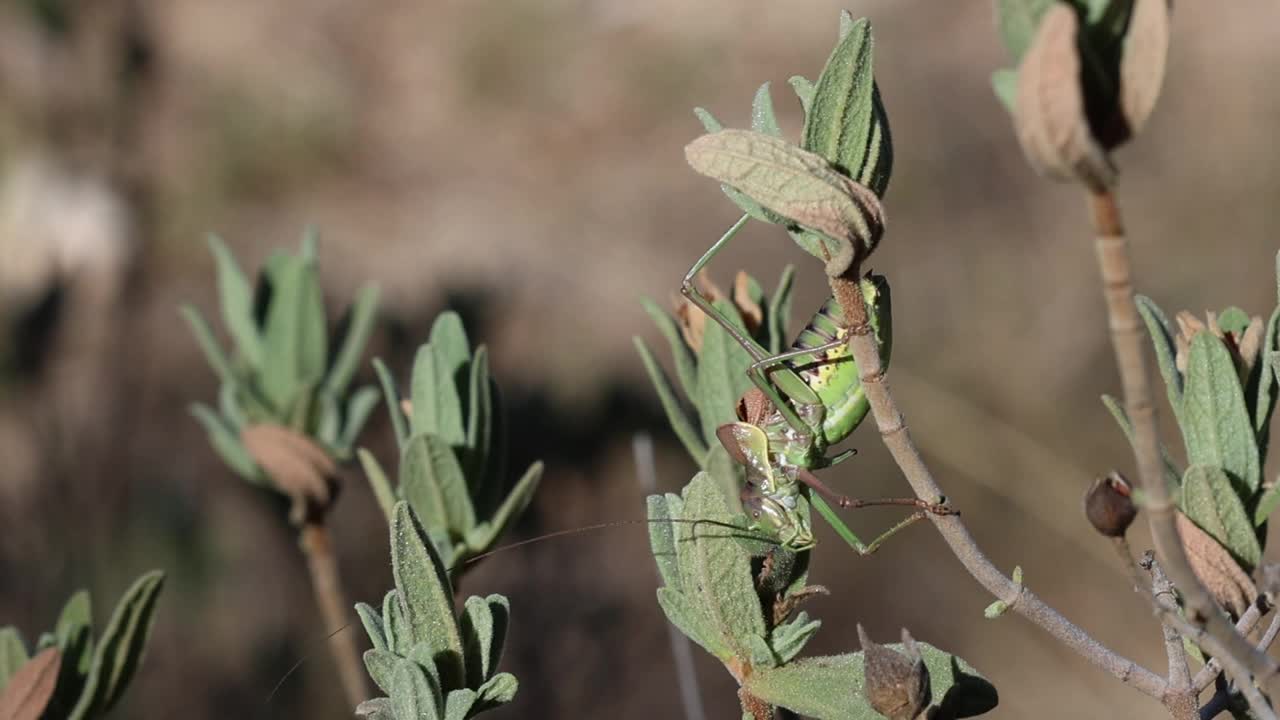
top-left (831, 268), bottom-right (1167, 698)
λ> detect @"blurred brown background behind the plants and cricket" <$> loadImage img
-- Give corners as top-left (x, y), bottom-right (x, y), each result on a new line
top-left (0, 0), bottom-right (1280, 720)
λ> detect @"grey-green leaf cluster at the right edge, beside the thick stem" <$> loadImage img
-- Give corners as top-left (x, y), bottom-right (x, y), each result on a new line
top-left (1103, 256), bottom-right (1280, 570)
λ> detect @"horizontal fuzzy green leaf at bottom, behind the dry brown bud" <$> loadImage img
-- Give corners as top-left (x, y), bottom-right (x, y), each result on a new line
top-left (742, 641), bottom-right (998, 720)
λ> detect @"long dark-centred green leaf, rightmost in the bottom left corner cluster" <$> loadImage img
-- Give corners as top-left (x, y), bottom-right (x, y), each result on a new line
top-left (68, 570), bottom-right (164, 720)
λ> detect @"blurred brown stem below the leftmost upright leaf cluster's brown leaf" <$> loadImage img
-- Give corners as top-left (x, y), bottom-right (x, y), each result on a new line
top-left (300, 520), bottom-right (369, 708)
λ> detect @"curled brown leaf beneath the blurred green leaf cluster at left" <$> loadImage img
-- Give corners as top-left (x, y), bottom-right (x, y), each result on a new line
top-left (241, 423), bottom-right (338, 524)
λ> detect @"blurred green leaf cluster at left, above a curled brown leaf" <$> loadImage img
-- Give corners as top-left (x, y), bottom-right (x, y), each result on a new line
top-left (182, 233), bottom-right (378, 486)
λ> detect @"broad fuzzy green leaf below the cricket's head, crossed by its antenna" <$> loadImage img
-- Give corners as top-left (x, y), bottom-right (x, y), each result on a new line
top-left (676, 473), bottom-right (767, 657)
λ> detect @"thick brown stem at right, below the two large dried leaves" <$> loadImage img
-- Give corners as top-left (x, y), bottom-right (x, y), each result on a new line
top-left (1089, 192), bottom-right (1277, 683)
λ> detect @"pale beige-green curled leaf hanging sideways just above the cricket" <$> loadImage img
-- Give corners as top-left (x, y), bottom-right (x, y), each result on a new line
top-left (685, 129), bottom-right (879, 277)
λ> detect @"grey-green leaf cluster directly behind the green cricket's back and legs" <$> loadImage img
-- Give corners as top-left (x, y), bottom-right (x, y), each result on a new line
top-left (634, 266), bottom-right (795, 492)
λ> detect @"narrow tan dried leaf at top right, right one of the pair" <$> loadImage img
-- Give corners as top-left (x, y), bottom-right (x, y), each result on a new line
top-left (1120, 0), bottom-right (1169, 135)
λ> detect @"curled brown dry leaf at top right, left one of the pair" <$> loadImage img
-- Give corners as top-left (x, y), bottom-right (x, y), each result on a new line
top-left (1014, 3), bottom-right (1115, 192)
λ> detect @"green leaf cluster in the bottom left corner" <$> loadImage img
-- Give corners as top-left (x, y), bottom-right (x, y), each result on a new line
top-left (0, 570), bottom-right (164, 720)
